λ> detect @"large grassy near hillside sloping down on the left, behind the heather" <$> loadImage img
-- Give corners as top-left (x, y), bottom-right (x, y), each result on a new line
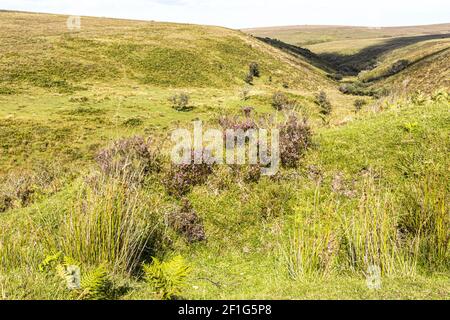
top-left (0, 12), bottom-right (348, 175)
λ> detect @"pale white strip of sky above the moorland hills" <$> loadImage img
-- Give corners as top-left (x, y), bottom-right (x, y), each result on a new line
top-left (0, 0), bottom-right (450, 28)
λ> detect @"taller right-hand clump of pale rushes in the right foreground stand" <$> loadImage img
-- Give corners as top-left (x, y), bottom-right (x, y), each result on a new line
top-left (340, 177), bottom-right (416, 276)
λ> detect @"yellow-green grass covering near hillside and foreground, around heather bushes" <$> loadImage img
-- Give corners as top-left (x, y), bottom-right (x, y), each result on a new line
top-left (0, 12), bottom-right (450, 299)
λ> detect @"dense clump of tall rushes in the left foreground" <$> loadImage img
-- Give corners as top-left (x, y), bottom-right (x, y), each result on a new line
top-left (57, 177), bottom-right (164, 272)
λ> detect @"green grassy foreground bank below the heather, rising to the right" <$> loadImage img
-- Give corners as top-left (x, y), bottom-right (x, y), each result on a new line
top-left (0, 97), bottom-right (450, 299)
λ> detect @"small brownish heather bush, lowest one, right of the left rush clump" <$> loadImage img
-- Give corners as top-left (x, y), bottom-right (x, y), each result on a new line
top-left (169, 199), bottom-right (206, 243)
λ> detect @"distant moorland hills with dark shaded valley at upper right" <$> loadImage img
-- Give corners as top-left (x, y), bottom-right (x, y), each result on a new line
top-left (245, 24), bottom-right (450, 93)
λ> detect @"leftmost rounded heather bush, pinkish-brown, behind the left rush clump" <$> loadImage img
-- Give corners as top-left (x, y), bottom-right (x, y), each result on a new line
top-left (96, 136), bottom-right (161, 182)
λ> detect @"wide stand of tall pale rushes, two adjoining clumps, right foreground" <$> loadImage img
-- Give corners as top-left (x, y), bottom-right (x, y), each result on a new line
top-left (281, 177), bottom-right (421, 279)
